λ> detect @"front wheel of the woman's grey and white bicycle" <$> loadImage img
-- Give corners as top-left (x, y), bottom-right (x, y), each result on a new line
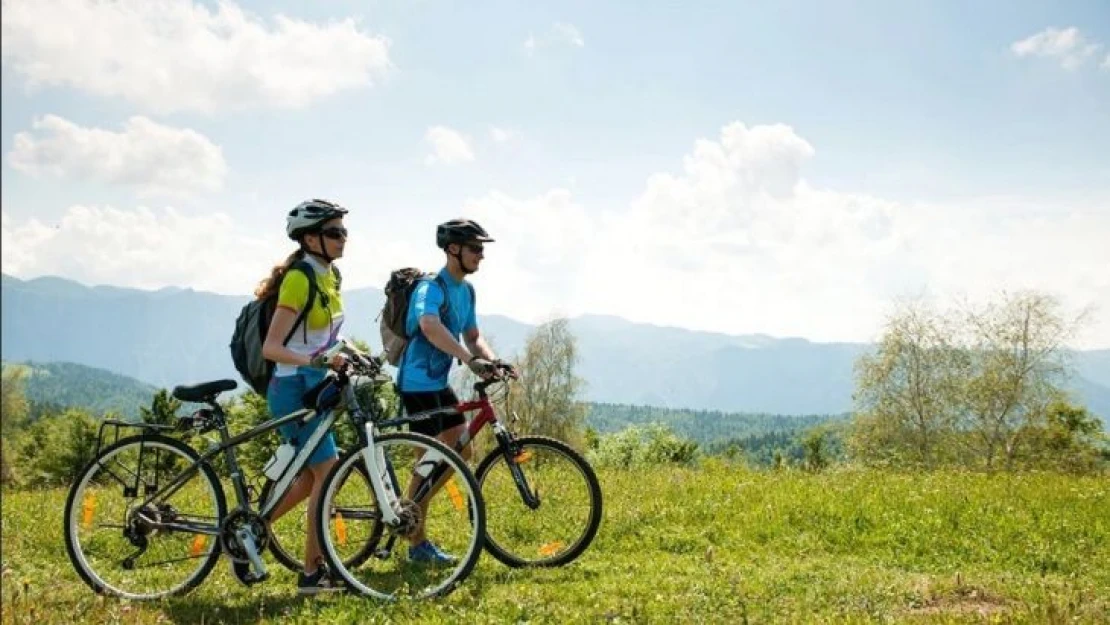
top-left (315, 432), bottom-right (485, 601)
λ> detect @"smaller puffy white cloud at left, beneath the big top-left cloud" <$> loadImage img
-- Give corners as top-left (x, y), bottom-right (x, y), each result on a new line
top-left (8, 115), bottom-right (228, 195)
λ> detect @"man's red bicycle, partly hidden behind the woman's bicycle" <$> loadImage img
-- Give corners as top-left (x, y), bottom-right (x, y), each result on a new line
top-left (262, 363), bottom-right (602, 571)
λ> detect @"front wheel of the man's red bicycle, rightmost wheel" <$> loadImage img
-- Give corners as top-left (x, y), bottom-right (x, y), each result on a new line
top-left (475, 436), bottom-right (602, 567)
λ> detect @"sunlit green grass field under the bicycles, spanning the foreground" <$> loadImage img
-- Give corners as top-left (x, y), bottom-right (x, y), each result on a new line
top-left (2, 461), bottom-right (1110, 624)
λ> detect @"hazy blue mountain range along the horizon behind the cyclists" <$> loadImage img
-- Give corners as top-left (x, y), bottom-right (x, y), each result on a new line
top-left (0, 274), bottom-right (1110, 420)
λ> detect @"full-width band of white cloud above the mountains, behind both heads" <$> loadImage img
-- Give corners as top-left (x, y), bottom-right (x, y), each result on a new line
top-left (8, 123), bottom-right (1110, 347)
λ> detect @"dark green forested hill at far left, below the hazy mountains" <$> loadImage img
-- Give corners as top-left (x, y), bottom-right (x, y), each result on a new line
top-left (3, 362), bottom-right (158, 419)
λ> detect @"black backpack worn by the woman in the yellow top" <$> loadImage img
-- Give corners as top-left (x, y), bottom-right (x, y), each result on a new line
top-left (229, 260), bottom-right (343, 395)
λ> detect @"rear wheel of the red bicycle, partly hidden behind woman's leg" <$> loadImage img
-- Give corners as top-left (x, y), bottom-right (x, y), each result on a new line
top-left (259, 463), bottom-right (384, 573)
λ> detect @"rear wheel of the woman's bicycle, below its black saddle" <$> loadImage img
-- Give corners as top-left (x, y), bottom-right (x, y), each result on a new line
top-left (64, 435), bottom-right (226, 599)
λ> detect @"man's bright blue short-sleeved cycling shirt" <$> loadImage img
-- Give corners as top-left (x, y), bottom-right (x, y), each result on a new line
top-left (397, 268), bottom-right (478, 393)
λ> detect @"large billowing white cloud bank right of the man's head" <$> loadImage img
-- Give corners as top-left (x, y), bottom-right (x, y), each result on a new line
top-left (464, 123), bottom-right (1110, 346)
